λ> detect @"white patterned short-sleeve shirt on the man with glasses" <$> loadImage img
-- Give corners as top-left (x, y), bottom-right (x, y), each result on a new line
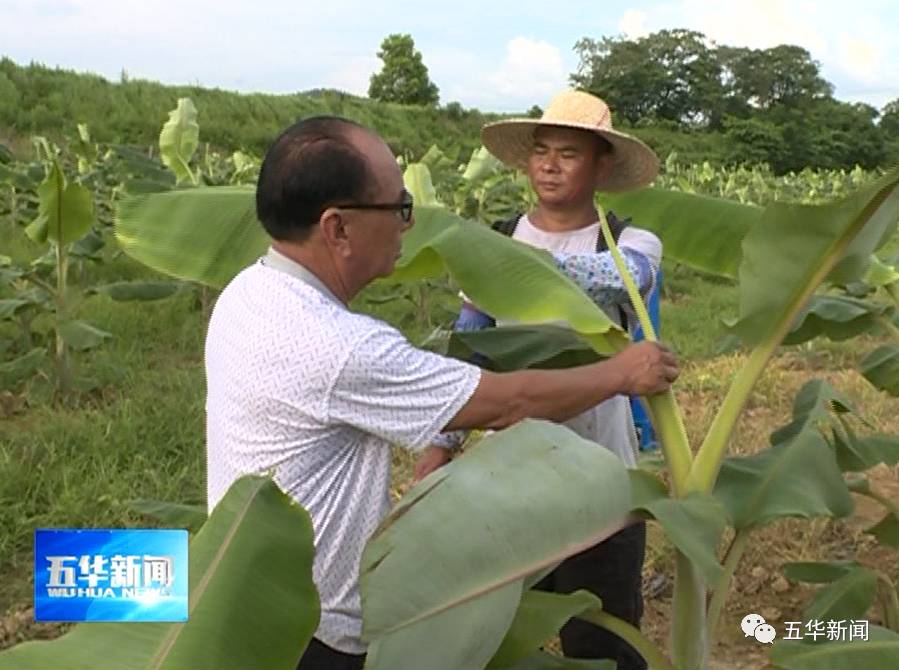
top-left (206, 252), bottom-right (481, 654)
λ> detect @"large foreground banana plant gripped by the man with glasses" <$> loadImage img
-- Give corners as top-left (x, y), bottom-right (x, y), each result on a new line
top-left (109, 152), bottom-right (899, 670)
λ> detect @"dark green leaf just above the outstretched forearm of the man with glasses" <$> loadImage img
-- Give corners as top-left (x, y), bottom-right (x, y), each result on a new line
top-left (447, 326), bottom-right (599, 372)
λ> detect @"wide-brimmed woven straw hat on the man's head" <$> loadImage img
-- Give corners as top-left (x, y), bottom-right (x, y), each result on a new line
top-left (481, 91), bottom-right (659, 191)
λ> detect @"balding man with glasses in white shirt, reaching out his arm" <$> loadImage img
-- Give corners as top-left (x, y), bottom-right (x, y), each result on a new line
top-left (206, 117), bottom-right (678, 670)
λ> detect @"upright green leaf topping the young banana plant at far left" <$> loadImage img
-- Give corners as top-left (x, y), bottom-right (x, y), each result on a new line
top-left (25, 161), bottom-right (94, 245)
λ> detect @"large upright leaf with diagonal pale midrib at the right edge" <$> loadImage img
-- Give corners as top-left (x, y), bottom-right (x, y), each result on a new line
top-left (736, 168), bottom-right (899, 345)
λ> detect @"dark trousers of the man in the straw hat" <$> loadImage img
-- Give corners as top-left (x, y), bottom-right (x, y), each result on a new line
top-left (534, 523), bottom-right (646, 670)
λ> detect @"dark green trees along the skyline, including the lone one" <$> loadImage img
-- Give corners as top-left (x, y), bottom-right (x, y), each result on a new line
top-left (368, 29), bottom-right (899, 174)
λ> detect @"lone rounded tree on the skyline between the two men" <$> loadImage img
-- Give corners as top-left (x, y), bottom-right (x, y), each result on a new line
top-left (368, 34), bottom-right (440, 105)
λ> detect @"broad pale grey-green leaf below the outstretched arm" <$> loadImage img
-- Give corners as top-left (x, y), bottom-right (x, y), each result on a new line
top-left (360, 420), bottom-right (630, 668)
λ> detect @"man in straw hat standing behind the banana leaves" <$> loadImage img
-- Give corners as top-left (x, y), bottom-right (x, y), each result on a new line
top-left (417, 91), bottom-right (662, 670)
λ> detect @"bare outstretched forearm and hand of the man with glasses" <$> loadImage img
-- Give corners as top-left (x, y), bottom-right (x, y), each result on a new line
top-left (445, 342), bottom-right (679, 430)
